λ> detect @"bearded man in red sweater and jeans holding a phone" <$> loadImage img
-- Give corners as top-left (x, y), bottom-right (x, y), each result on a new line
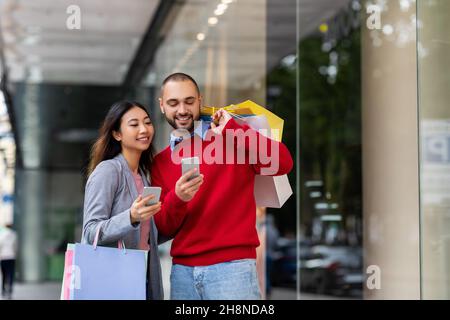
top-left (151, 73), bottom-right (293, 300)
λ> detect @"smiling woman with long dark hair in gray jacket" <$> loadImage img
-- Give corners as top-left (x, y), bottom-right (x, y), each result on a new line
top-left (82, 101), bottom-right (163, 299)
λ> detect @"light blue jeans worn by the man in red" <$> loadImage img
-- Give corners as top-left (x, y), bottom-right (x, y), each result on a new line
top-left (170, 259), bottom-right (261, 300)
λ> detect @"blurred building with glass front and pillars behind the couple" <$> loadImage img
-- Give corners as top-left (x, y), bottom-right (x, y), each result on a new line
top-left (0, 0), bottom-right (450, 299)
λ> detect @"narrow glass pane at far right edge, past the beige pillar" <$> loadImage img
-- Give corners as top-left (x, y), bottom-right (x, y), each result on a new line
top-left (417, 1), bottom-right (450, 300)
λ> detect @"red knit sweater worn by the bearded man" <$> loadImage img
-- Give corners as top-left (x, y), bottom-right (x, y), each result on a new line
top-left (151, 119), bottom-right (293, 266)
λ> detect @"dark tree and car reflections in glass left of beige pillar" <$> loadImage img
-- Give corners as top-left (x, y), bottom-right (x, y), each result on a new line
top-left (299, 1), bottom-right (363, 299)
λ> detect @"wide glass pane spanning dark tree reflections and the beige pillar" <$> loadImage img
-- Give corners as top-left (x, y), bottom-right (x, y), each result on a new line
top-left (298, 0), bottom-right (421, 299)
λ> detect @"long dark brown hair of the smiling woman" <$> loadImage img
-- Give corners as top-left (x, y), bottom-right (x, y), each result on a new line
top-left (88, 101), bottom-right (155, 176)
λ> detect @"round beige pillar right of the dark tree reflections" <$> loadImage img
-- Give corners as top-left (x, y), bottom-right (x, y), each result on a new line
top-left (361, 1), bottom-right (420, 299)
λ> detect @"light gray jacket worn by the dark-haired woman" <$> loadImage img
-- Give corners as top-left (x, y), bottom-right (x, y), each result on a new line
top-left (82, 154), bottom-right (164, 300)
